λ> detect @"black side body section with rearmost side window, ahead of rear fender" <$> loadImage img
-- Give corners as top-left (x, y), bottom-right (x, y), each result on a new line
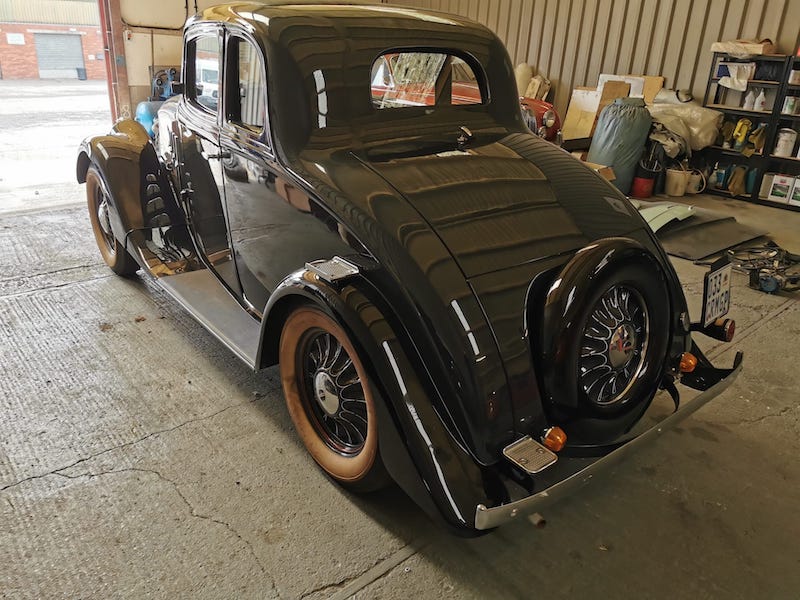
top-left (220, 27), bottom-right (351, 314)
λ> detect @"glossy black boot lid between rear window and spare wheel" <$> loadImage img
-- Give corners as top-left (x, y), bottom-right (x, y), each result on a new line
top-left (362, 134), bottom-right (643, 278)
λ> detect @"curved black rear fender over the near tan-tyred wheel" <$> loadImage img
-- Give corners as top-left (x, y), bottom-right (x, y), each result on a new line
top-left (256, 270), bottom-right (487, 535)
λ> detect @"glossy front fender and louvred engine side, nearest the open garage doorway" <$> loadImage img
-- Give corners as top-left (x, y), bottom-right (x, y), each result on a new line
top-left (76, 119), bottom-right (185, 257)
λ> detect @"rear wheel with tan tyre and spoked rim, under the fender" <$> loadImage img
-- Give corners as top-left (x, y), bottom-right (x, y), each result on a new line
top-left (279, 306), bottom-right (388, 492)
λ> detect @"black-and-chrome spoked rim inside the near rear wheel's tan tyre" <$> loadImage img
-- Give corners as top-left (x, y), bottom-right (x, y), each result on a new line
top-left (303, 331), bottom-right (367, 455)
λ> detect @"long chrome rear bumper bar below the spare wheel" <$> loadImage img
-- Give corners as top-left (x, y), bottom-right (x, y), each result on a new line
top-left (475, 362), bottom-right (742, 530)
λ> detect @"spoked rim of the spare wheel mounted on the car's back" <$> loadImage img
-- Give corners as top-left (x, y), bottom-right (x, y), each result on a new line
top-left (578, 285), bottom-right (650, 406)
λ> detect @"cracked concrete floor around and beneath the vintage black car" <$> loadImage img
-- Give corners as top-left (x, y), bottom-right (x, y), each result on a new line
top-left (0, 81), bottom-right (800, 600)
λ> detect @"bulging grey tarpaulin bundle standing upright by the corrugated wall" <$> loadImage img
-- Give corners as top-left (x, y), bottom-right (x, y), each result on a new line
top-left (587, 98), bottom-right (652, 194)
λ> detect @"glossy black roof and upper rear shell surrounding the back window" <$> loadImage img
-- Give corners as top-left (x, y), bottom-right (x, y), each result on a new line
top-left (186, 0), bottom-right (521, 155)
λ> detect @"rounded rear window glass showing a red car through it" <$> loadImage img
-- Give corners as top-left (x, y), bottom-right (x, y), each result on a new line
top-left (371, 52), bottom-right (486, 109)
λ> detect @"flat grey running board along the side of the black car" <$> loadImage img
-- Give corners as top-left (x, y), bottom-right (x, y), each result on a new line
top-left (156, 269), bottom-right (261, 369)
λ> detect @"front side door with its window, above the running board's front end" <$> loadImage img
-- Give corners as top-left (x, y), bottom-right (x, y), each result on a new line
top-left (177, 24), bottom-right (241, 297)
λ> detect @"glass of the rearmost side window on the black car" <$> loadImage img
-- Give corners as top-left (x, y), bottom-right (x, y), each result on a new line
top-left (227, 37), bottom-right (266, 131)
